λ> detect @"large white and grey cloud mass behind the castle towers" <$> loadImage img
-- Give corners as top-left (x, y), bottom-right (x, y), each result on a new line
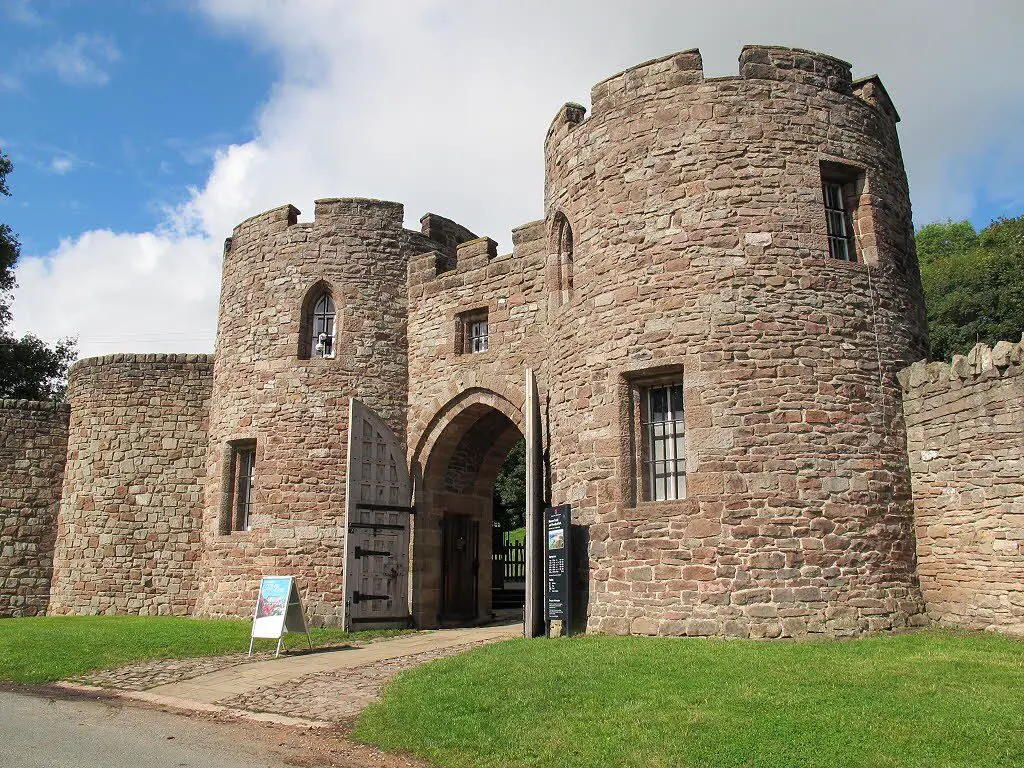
top-left (15, 0), bottom-right (1024, 353)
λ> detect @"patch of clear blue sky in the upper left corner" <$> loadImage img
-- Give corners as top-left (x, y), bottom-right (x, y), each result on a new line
top-left (0, 0), bottom-right (274, 259)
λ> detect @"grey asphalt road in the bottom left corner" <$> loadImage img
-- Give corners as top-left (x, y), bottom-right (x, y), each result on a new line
top-left (0, 691), bottom-right (308, 768)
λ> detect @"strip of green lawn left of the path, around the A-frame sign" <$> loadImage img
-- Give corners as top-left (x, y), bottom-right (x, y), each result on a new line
top-left (0, 616), bottom-right (407, 683)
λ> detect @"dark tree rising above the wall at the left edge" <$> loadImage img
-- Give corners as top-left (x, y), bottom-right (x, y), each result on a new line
top-left (0, 152), bottom-right (76, 400)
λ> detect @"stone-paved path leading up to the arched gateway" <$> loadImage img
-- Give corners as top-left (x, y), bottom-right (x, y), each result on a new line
top-left (82, 624), bottom-right (522, 721)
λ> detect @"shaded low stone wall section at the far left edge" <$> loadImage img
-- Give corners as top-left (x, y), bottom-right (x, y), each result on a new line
top-left (0, 399), bottom-right (70, 617)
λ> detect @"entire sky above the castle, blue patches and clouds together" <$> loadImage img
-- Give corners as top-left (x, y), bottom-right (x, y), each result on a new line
top-left (0, 0), bottom-right (1024, 355)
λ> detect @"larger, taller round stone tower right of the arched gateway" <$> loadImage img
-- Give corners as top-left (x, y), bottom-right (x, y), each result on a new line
top-left (545, 47), bottom-right (927, 637)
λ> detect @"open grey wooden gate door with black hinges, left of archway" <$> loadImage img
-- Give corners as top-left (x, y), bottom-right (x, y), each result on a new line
top-left (344, 397), bottom-right (414, 630)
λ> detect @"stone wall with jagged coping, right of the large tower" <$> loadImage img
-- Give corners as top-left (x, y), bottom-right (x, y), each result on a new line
top-left (900, 339), bottom-right (1024, 635)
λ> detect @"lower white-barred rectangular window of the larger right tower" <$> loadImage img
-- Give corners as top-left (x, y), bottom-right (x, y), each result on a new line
top-left (637, 381), bottom-right (686, 502)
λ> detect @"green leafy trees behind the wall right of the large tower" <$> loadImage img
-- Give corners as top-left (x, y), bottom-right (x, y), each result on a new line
top-left (916, 217), bottom-right (1024, 359)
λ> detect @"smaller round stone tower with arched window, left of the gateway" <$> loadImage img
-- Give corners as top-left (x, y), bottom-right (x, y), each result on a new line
top-left (197, 199), bottom-right (429, 624)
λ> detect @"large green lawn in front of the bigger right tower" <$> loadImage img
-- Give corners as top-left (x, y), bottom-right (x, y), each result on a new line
top-left (354, 632), bottom-right (1024, 768)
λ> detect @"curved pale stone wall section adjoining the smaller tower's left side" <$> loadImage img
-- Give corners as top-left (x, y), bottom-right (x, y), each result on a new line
top-left (50, 354), bottom-right (213, 615)
